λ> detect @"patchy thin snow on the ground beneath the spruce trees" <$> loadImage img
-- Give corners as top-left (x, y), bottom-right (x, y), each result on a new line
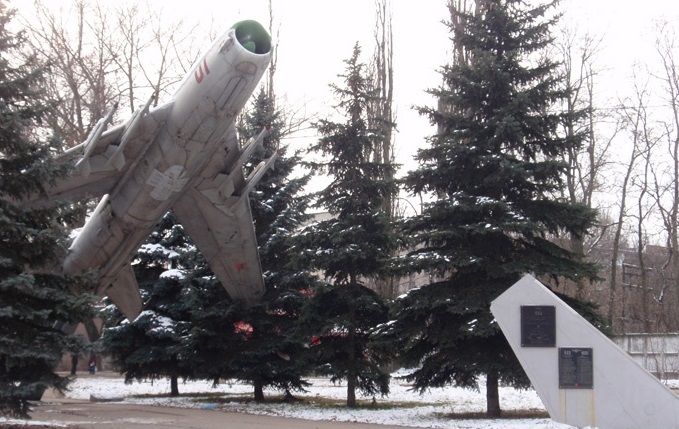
top-left (67, 377), bottom-right (570, 429)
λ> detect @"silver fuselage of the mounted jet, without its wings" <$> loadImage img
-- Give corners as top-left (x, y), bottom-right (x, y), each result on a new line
top-left (64, 20), bottom-right (270, 304)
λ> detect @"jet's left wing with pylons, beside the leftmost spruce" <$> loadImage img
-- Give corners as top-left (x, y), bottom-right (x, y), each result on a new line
top-left (26, 96), bottom-right (172, 207)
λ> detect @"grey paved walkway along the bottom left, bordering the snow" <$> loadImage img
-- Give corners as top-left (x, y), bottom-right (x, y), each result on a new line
top-left (31, 399), bottom-right (420, 429)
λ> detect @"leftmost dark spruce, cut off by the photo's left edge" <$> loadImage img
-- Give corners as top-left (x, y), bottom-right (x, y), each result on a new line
top-left (0, 0), bottom-right (90, 416)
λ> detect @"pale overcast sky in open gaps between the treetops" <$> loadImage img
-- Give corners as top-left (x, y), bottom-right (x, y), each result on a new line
top-left (12, 0), bottom-right (679, 213)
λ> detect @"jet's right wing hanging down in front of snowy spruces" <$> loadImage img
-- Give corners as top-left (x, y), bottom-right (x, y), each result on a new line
top-left (172, 130), bottom-right (264, 304)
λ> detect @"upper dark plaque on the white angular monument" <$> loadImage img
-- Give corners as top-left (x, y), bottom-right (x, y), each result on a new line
top-left (521, 305), bottom-right (556, 347)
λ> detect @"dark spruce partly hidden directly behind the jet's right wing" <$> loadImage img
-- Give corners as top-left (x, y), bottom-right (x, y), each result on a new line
top-left (227, 89), bottom-right (316, 401)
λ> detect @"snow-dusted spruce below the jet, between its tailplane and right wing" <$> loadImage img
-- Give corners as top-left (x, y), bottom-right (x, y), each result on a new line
top-left (99, 227), bottom-right (247, 395)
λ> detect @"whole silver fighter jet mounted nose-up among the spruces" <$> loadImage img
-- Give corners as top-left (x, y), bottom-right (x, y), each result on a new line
top-left (31, 21), bottom-right (275, 320)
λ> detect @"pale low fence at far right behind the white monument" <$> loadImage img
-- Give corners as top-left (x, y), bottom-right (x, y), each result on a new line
top-left (612, 333), bottom-right (679, 380)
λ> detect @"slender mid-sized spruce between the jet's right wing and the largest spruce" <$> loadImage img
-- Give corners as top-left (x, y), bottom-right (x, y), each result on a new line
top-left (303, 44), bottom-right (395, 407)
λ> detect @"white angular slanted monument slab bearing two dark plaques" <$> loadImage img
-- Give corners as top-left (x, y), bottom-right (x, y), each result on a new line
top-left (490, 275), bottom-right (679, 429)
